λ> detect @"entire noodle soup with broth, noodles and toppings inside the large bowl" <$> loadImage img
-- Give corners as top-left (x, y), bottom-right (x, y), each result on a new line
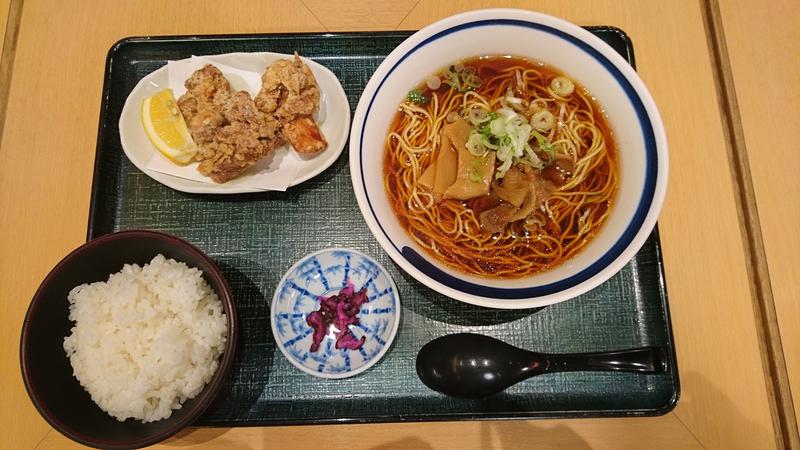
top-left (384, 57), bottom-right (619, 278)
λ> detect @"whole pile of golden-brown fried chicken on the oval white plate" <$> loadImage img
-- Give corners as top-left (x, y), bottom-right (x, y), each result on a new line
top-left (170, 53), bottom-right (328, 183)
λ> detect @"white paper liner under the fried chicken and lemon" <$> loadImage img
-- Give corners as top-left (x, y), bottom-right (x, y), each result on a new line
top-left (146, 54), bottom-right (302, 191)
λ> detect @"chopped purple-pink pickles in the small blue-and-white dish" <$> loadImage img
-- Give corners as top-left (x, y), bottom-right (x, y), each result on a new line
top-left (306, 280), bottom-right (367, 352)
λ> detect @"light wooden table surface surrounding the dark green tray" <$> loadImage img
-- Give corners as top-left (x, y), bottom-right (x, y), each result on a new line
top-left (0, 0), bottom-right (800, 449)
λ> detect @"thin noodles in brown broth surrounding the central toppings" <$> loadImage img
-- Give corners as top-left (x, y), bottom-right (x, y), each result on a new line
top-left (384, 57), bottom-right (618, 278)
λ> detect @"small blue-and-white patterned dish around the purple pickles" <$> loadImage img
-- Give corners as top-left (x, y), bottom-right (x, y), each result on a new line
top-left (271, 248), bottom-right (400, 378)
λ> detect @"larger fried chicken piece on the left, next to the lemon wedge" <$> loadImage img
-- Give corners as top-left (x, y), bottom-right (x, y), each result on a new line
top-left (178, 64), bottom-right (282, 183)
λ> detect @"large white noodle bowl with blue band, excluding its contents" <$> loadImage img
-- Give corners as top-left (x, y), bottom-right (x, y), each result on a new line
top-left (350, 9), bottom-right (667, 309)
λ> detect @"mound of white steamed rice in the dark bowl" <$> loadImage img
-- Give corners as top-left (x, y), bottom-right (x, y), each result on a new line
top-left (64, 255), bottom-right (227, 422)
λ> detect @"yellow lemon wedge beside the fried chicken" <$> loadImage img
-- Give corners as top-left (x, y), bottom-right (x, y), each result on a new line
top-left (142, 89), bottom-right (197, 165)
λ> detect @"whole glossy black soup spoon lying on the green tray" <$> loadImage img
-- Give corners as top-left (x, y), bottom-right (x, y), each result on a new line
top-left (417, 333), bottom-right (667, 397)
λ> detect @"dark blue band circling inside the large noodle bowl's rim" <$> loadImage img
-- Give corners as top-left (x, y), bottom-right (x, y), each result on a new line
top-left (358, 19), bottom-right (658, 300)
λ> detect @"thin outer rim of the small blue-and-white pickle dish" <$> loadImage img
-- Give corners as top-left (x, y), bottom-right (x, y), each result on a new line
top-left (269, 247), bottom-right (401, 380)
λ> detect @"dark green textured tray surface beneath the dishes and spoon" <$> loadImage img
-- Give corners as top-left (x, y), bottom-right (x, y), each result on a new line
top-left (89, 27), bottom-right (678, 425)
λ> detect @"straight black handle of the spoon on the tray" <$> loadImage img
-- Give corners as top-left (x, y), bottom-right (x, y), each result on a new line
top-left (543, 347), bottom-right (667, 373)
